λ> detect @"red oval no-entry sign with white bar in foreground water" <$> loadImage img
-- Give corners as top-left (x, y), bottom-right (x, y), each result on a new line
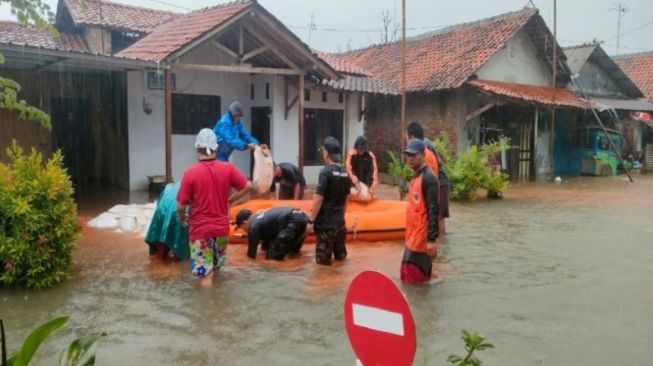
top-left (345, 271), bottom-right (416, 366)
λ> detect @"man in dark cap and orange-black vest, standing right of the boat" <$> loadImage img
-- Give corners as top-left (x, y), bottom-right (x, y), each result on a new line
top-left (400, 139), bottom-right (439, 283)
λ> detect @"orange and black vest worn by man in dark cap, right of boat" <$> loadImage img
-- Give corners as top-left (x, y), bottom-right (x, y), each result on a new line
top-left (406, 166), bottom-right (439, 253)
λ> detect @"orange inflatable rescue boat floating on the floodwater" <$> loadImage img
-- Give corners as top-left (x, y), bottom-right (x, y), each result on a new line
top-left (229, 200), bottom-right (406, 243)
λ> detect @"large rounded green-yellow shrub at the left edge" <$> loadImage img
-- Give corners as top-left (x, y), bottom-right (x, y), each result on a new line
top-left (0, 141), bottom-right (80, 288)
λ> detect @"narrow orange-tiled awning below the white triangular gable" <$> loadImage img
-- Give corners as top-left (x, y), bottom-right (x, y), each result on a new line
top-left (467, 80), bottom-right (587, 108)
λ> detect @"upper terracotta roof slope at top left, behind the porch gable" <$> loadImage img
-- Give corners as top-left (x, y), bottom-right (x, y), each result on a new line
top-left (63, 0), bottom-right (180, 33)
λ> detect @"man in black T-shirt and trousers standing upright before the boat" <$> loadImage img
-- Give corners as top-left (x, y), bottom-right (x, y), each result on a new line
top-left (311, 137), bottom-right (352, 266)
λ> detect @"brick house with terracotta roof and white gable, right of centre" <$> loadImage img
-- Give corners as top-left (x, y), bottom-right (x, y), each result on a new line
top-left (324, 8), bottom-right (584, 179)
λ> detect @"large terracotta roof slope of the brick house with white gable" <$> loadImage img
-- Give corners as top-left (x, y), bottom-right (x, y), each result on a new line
top-left (332, 8), bottom-right (538, 91)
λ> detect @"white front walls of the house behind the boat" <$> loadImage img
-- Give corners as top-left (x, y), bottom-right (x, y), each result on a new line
top-left (127, 67), bottom-right (364, 190)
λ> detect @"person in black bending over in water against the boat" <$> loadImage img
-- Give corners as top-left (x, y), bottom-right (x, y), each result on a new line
top-left (236, 207), bottom-right (308, 261)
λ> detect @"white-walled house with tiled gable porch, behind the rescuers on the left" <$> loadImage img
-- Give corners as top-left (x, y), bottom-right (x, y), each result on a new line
top-left (0, 0), bottom-right (366, 190)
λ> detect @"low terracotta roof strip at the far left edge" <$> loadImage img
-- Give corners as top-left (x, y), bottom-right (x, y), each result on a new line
top-left (0, 21), bottom-right (89, 52)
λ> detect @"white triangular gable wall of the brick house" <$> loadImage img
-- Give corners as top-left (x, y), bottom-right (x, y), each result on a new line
top-left (477, 30), bottom-right (551, 86)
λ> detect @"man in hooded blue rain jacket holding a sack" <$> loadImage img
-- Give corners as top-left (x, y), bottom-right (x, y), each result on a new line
top-left (213, 101), bottom-right (259, 161)
